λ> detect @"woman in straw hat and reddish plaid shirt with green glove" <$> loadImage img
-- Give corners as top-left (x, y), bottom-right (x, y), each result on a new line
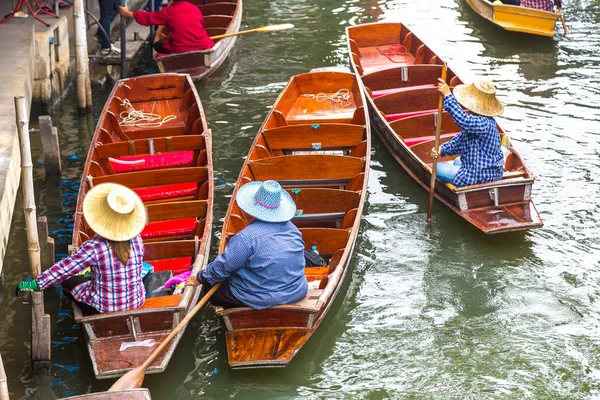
top-left (17, 183), bottom-right (146, 314)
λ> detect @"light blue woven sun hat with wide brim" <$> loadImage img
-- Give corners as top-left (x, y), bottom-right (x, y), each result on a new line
top-left (236, 181), bottom-right (296, 222)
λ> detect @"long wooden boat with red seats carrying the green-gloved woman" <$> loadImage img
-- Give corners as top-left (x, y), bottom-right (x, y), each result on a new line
top-left (72, 74), bottom-right (213, 378)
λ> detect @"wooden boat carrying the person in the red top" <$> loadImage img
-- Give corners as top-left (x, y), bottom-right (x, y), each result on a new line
top-left (154, 0), bottom-right (242, 81)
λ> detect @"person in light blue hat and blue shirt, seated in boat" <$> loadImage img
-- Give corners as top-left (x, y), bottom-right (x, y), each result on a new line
top-left (186, 181), bottom-right (308, 310)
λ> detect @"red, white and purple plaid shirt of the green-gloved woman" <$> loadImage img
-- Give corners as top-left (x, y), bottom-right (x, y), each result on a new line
top-left (36, 235), bottom-right (146, 313)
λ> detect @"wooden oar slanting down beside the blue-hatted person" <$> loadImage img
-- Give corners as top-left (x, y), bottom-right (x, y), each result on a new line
top-left (108, 254), bottom-right (222, 392)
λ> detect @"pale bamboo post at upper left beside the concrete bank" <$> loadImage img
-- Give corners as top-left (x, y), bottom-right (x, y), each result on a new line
top-left (73, 0), bottom-right (92, 113)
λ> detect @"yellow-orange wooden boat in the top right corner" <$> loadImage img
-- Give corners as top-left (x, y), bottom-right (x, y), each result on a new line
top-left (466, 0), bottom-right (561, 37)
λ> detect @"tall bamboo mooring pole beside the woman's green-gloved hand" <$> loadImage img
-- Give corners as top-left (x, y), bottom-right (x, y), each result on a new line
top-left (15, 96), bottom-right (51, 373)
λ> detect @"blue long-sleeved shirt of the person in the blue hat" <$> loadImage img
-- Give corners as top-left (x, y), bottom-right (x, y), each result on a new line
top-left (202, 220), bottom-right (308, 310)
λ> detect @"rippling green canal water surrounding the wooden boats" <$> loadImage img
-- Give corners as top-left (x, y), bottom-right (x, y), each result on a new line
top-left (0, 0), bottom-right (600, 400)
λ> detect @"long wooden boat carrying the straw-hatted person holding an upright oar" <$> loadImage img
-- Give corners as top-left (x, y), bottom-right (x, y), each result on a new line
top-left (346, 22), bottom-right (542, 233)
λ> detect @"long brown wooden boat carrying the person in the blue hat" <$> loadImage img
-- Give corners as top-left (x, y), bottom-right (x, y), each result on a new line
top-left (216, 72), bottom-right (371, 368)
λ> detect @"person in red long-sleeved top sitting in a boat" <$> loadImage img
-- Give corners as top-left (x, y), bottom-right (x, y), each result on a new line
top-left (119, 0), bottom-right (215, 54)
